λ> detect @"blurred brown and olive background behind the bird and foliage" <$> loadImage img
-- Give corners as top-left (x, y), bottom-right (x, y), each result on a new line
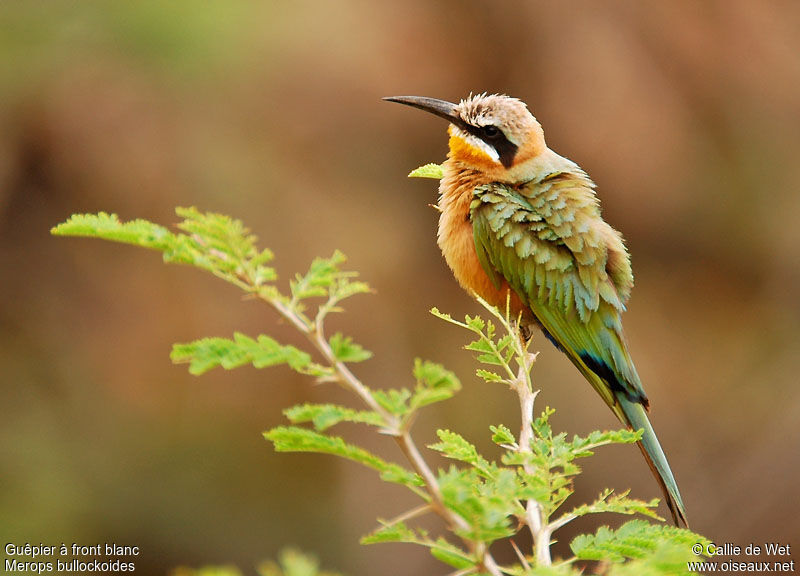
top-left (0, 0), bottom-right (800, 575)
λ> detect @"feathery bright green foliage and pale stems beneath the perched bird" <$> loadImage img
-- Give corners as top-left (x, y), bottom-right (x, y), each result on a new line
top-left (52, 208), bottom-right (707, 576)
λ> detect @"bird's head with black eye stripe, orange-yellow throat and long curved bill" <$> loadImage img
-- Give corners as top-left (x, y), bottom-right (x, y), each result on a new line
top-left (384, 94), bottom-right (547, 181)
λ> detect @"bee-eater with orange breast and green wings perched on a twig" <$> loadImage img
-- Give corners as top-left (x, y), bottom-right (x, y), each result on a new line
top-left (384, 93), bottom-right (688, 527)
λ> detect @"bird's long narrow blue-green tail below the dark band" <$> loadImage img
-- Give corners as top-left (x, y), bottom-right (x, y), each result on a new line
top-left (615, 392), bottom-right (689, 527)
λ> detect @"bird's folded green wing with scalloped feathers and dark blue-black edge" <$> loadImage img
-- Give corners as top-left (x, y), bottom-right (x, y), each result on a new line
top-left (470, 174), bottom-right (647, 408)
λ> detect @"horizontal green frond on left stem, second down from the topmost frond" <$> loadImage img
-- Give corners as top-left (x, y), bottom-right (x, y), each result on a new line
top-left (170, 332), bottom-right (311, 375)
